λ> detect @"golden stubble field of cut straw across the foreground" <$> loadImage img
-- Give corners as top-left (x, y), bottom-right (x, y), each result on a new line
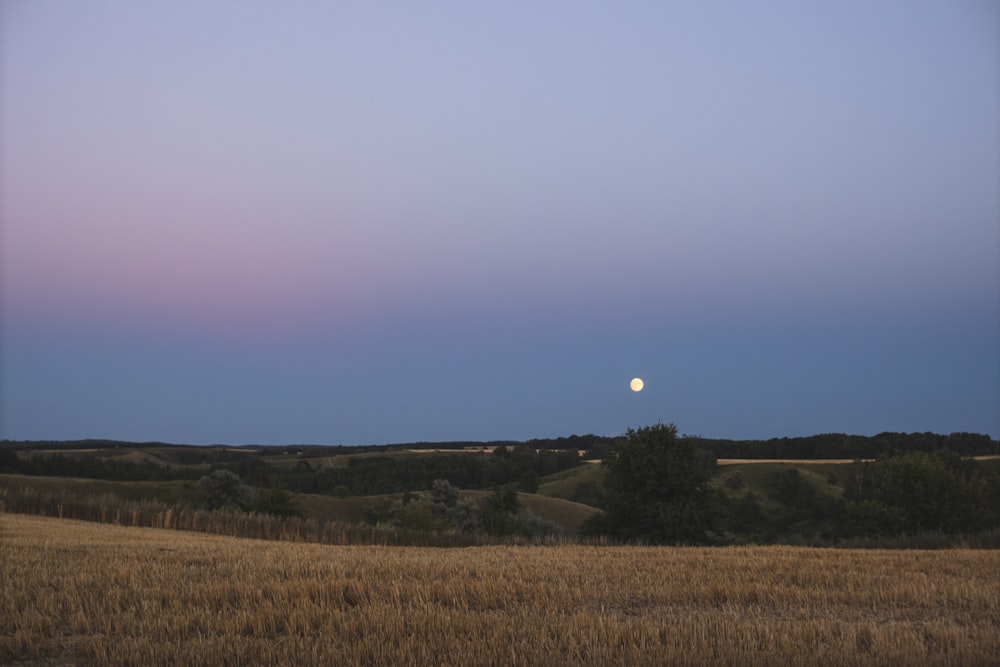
top-left (0, 514), bottom-right (1000, 665)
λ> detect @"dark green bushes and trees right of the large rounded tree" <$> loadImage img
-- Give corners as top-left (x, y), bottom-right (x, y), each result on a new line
top-left (720, 450), bottom-right (1000, 545)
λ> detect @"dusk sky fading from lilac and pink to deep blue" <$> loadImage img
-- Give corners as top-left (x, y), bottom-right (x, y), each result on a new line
top-left (0, 0), bottom-right (1000, 444)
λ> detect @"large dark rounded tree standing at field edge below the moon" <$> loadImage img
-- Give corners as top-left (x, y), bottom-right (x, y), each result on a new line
top-left (588, 423), bottom-right (721, 544)
